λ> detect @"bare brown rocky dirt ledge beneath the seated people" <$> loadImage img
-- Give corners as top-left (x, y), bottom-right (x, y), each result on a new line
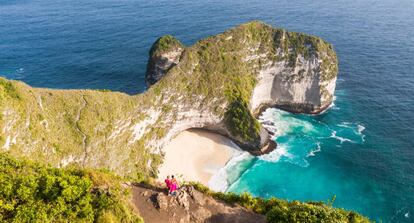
top-left (133, 185), bottom-right (266, 223)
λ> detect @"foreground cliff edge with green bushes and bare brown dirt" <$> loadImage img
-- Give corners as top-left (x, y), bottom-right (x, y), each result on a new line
top-left (0, 152), bottom-right (369, 223)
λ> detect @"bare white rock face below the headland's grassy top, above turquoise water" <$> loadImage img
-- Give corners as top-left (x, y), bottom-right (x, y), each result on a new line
top-left (250, 55), bottom-right (336, 113)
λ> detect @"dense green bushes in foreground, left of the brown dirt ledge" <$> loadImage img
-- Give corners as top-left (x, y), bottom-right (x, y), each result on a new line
top-left (0, 153), bottom-right (143, 222)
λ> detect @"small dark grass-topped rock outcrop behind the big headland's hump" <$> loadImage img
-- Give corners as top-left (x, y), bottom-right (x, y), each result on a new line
top-left (145, 35), bottom-right (184, 87)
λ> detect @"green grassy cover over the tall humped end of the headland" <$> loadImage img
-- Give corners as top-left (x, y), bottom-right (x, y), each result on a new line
top-left (150, 21), bottom-right (336, 143)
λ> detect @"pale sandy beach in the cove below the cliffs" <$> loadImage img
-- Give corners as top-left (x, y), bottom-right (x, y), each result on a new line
top-left (158, 130), bottom-right (237, 185)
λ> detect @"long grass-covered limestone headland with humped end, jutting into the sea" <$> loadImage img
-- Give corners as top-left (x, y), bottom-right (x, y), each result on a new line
top-left (0, 22), bottom-right (338, 177)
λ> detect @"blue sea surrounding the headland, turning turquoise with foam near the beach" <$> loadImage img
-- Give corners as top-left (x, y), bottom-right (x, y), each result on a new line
top-left (0, 0), bottom-right (414, 222)
